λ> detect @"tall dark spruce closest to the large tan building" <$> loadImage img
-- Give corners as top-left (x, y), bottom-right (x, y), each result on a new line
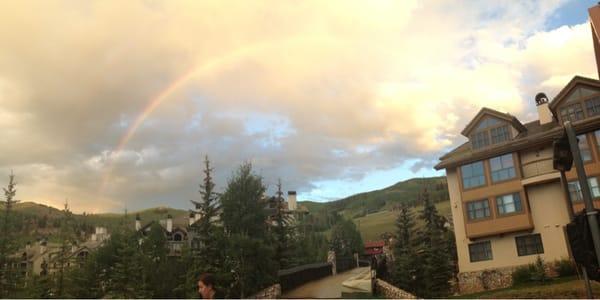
top-left (420, 188), bottom-right (452, 298)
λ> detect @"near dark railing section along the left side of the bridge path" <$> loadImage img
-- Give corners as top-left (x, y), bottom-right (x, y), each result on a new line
top-left (277, 263), bottom-right (332, 292)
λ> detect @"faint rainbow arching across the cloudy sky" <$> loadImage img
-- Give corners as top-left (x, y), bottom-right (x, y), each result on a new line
top-left (100, 36), bottom-right (340, 192)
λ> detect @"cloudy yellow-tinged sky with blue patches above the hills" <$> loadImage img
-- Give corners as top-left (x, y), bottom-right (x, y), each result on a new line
top-left (0, 0), bottom-right (597, 213)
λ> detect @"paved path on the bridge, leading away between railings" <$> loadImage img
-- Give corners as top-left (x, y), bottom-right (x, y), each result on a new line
top-left (281, 267), bottom-right (369, 298)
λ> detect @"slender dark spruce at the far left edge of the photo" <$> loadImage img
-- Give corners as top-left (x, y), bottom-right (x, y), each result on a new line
top-left (0, 171), bottom-right (22, 298)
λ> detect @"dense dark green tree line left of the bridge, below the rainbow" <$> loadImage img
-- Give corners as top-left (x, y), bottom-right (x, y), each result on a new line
top-left (0, 157), bottom-right (362, 298)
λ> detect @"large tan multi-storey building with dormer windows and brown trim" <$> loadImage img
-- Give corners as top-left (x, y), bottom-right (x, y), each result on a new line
top-left (435, 6), bottom-right (600, 293)
